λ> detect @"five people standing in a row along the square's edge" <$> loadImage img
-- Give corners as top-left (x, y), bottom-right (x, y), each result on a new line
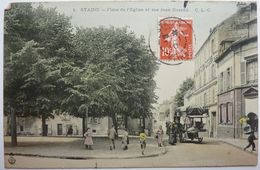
top-left (84, 125), bottom-right (164, 155)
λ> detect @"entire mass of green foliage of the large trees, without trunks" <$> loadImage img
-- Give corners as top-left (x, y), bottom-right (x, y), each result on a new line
top-left (4, 3), bottom-right (157, 123)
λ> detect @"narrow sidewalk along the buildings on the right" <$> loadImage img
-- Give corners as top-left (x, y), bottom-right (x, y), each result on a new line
top-left (207, 138), bottom-right (258, 155)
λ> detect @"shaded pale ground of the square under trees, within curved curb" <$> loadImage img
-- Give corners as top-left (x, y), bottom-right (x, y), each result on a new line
top-left (4, 137), bottom-right (166, 159)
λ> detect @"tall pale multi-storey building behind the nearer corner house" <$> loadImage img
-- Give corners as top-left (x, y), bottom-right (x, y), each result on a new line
top-left (185, 2), bottom-right (254, 137)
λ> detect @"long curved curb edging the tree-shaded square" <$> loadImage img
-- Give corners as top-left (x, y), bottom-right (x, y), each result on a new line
top-left (4, 147), bottom-right (167, 160)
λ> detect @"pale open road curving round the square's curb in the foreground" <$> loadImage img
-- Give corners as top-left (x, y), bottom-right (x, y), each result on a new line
top-left (5, 141), bottom-right (258, 168)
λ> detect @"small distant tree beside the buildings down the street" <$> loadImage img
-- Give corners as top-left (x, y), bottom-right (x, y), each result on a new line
top-left (174, 78), bottom-right (194, 107)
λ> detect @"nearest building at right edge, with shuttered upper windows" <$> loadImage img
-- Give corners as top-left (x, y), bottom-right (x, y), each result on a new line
top-left (215, 3), bottom-right (258, 138)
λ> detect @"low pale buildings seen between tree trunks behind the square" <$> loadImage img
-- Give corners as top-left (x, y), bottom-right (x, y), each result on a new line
top-left (4, 114), bottom-right (152, 136)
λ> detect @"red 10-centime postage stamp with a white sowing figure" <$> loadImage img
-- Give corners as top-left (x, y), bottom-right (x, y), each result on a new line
top-left (160, 17), bottom-right (193, 60)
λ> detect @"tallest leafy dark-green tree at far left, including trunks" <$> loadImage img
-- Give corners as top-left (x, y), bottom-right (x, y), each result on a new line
top-left (4, 3), bottom-right (72, 145)
